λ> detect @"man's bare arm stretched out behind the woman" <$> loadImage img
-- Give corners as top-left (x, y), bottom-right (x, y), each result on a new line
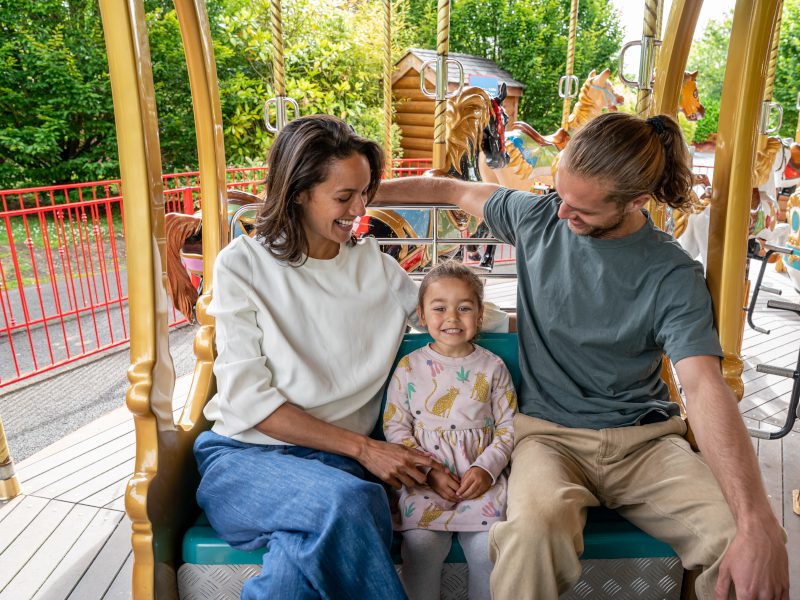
top-left (370, 177), bottom-right (500, 219)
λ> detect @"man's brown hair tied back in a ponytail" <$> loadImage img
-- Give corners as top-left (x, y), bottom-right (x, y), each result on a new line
top-left (559, 112), bottom-right (692, 208)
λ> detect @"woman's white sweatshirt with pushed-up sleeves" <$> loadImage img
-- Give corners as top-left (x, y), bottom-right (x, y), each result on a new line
top-left (203, 236), bottom-right (508, 444)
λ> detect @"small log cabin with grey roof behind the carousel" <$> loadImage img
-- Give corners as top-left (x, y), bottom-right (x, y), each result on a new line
top-left (392, 48), bottom-right (525, 158)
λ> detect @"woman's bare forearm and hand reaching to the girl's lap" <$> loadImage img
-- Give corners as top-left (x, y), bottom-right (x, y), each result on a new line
top-left (256, 402), bottom-right (442, 489)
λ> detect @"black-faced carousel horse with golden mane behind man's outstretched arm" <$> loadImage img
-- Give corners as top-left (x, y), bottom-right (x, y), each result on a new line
top-left (356, 84), bottom-right (508, 272)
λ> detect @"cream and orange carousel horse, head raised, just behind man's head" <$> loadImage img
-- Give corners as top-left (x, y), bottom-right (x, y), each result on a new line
top-left (480, 69), bottom-right (624, 191)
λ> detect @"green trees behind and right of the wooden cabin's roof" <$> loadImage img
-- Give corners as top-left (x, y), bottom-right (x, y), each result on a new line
top-left (404, 0), bottom-right (622, 133)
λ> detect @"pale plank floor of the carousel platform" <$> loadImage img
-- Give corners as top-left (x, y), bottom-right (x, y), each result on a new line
top-left (0, 272), bottom-right (800, 600)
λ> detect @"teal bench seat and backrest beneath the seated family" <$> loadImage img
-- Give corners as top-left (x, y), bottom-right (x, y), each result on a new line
top-left (183, 333), bottom-right (675, 565)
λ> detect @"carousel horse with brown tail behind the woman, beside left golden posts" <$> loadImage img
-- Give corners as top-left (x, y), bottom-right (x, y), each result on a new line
top-left (164, 190), bottom-right (263, 323)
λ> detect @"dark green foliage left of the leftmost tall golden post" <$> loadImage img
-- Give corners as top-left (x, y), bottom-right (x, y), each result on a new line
top-left (0, 0), bottom-right (118, 188)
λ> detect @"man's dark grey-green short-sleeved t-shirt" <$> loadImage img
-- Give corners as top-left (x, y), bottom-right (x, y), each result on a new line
top-left (484, 189), bottom-right (722, 429)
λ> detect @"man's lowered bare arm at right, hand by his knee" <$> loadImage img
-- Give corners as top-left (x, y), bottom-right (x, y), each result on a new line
top-left (675, 356), bottom-right (789, 600)
